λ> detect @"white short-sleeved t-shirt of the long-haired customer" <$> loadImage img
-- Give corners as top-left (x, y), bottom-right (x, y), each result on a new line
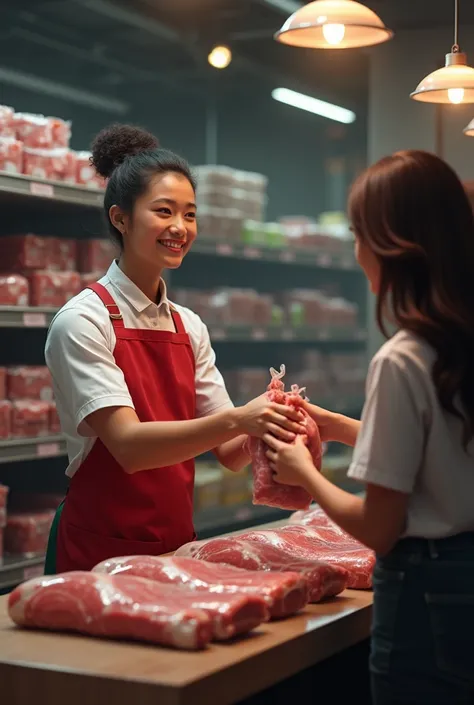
top-left (348, 331), bottom-right (474, 538)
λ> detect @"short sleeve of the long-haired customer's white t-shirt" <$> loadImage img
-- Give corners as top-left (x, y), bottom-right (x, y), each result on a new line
top-left (348, 356), bottom-right (426, 494)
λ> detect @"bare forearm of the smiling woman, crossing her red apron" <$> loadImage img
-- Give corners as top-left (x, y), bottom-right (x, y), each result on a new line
top-left (115, 409), bottom-right (241, 473)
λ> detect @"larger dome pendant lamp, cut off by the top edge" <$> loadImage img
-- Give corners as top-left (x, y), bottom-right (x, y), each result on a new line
top-left (275, 0), bottom-right (393, 49)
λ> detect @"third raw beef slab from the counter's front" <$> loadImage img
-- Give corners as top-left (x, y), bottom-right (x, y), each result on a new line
top-left (175, 536), bottom-right (349, 602)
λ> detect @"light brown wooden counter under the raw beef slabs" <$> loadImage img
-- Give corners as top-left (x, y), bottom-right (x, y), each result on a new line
top-left (0, 590), bottom-right (372, 705)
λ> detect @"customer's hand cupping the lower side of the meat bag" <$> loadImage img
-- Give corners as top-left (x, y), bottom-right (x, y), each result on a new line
top-left (263, 433), bottom-right (318, 489)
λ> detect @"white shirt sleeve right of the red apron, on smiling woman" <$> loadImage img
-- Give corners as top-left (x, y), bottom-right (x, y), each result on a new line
top-left (195, 319), bottom-right (234, 418)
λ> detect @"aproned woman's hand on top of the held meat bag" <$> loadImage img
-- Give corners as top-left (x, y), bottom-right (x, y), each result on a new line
top-left (238, 394), bottom-right (305, 443)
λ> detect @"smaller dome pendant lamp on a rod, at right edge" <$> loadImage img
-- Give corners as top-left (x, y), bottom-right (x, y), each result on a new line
top-left (410, 0), bottom-right (474, 105)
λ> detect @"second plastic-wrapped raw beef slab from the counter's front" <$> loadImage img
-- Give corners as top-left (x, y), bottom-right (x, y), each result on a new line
top-left (94, 556), bottom-right (308, 618)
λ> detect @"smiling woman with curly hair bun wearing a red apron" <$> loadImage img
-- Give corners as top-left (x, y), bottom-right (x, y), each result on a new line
top-left (46, 126), bottom-right (302, 573)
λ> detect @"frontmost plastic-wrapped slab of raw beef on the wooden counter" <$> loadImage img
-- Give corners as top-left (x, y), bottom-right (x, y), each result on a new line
top-left (9, 572), bottom-right (269, 648)
